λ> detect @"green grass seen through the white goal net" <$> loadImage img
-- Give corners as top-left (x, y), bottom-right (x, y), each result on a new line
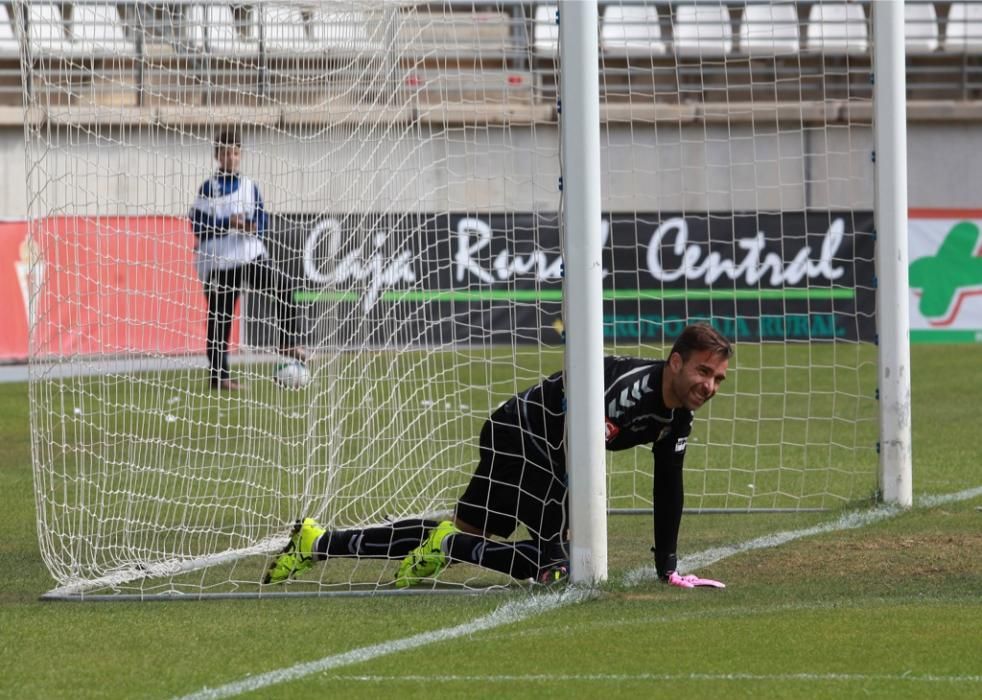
top-left (32, 343), bottom-right (876, 591)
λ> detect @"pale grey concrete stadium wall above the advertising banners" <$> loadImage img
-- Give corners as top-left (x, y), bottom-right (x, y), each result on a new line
top-left (0, 123), bottom-right (982, 218)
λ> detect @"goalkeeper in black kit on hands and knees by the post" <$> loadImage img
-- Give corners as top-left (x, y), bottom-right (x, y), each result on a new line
top-left (263, 324), bottom-right (733, 588)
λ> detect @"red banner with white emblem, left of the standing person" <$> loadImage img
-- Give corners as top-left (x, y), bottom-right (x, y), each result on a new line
top-left (0, 216), bottom-right (227, 361)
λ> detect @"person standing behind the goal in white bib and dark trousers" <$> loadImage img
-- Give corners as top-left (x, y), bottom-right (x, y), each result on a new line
top-left (190, 130), bottom-right (307, 391)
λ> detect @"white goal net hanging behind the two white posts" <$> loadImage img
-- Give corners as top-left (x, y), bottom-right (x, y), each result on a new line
top-left (21, 0), bottom-right (877, 596)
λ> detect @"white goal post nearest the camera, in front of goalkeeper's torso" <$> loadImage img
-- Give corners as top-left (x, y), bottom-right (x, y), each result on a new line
top-left (559, 0), bottom-right (607, 584)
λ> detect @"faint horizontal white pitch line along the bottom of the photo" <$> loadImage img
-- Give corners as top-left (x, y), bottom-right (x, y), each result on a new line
top-left (316, 673), bottom-right (982, 685)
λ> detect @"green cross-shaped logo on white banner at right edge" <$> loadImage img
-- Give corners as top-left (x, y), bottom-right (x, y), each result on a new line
top-left (910, 221), bottom-right (982, 322)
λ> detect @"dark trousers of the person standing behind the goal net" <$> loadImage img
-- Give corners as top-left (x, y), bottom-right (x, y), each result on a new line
top-left (205, 256), bottom-right (303, 383)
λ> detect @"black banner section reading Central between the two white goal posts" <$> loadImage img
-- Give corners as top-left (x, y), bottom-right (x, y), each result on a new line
top-left (604, 212), bottom-right (876, 341)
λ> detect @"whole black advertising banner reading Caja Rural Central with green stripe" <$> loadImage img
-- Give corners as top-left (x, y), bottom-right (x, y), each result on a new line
top-left (262, 212), bottom-right (875, 347)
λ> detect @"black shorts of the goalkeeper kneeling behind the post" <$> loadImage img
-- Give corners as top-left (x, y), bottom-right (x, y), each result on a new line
top-left (456, 409), bottom-right (568, 542)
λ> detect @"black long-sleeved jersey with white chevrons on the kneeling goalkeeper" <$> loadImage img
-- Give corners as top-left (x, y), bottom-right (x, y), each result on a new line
top-left (491, 356), bottom-right (692, 573)
